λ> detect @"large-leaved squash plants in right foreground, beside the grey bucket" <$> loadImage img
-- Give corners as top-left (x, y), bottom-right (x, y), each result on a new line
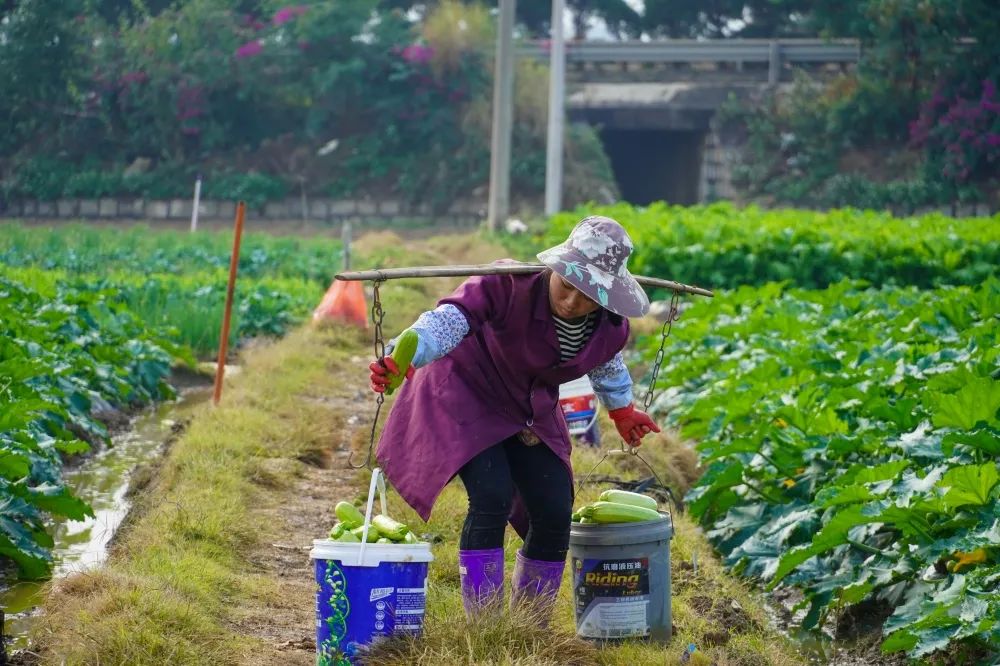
top-left (647, 279), bottom-right (1000, 656)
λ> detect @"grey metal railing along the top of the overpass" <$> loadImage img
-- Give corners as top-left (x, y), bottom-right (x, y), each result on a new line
top-left (517, 39), bottom-right (861, 83)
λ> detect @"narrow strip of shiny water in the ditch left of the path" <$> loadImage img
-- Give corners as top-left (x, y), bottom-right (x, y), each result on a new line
top-left (0, 387), bottom-right (211, 650)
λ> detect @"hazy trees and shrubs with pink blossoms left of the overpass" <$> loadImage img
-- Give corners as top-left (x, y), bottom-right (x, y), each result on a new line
top-left (0, 0), bottom-right (613, 208)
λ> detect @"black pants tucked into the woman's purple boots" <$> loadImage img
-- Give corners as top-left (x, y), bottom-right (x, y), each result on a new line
top-left (458, 435), bottom-right (573, 562)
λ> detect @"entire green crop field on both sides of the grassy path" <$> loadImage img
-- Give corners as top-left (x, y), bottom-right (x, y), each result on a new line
top-left (0, 204), bottom-right (1000, 663)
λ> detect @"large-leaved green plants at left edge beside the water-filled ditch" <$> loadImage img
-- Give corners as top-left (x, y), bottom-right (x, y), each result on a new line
top-left (0, 275), bottom-right (191, 578)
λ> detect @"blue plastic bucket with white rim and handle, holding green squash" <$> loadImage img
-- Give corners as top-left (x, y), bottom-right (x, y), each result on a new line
top-left (309, 468), bottom-right (434, 666)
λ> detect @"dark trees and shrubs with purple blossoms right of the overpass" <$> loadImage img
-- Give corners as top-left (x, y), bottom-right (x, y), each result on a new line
top-left (736, 0), bottom-right (1000, 210)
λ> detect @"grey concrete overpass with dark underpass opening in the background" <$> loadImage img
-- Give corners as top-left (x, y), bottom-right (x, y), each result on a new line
top-left (519, 40), bottom-right (860, 204)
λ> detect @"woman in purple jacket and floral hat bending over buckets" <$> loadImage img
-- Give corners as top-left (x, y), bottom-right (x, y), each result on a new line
top-left (370, 217), bottom-right (659, 614)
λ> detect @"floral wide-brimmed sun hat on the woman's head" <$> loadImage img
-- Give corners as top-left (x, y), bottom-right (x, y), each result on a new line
top-left (538, 215), bottom-right (649, 317)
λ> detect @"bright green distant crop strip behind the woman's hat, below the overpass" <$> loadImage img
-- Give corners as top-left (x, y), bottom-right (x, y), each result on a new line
top-left (548, 203), bottom-right (1000, 289)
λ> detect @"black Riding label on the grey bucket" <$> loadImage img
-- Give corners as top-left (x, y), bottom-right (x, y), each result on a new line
top-left (573, 557), bottom-right (649, 638)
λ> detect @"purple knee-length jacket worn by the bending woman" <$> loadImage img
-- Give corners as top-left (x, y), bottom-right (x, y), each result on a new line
top-left (376, 272), bottom-right (629, 532)
